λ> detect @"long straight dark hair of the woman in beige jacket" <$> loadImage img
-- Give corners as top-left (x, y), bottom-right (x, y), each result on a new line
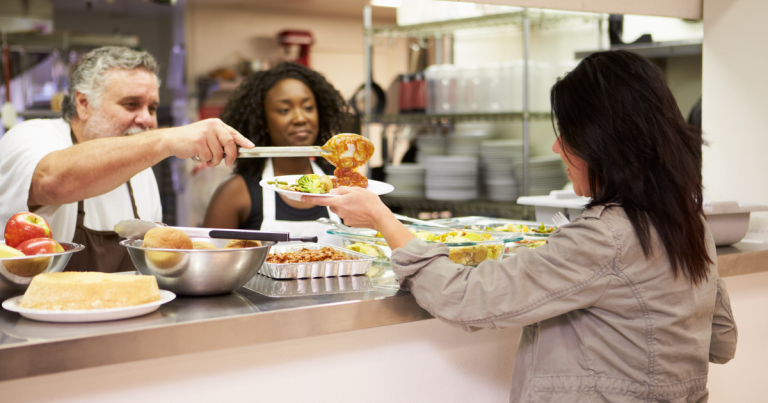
top-left (550, 51), bottom-right (712, 284)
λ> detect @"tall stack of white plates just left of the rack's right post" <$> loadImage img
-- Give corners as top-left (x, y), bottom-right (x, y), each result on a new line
top-left (480, 140), bottom-right (523, 201)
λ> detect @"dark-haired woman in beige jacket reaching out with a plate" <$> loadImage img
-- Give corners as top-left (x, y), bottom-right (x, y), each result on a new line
top-left (305, 51), bottom-right (737, 403)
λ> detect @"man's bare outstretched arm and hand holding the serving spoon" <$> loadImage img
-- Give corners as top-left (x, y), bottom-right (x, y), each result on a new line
top-left (27, 119), bottom-right (253, 208)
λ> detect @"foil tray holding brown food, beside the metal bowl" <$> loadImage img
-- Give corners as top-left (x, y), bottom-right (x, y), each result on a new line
top-left (259, 244), bottom-right (374, 279)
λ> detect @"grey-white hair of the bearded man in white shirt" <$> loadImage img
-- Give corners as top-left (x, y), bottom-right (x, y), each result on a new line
top-left (61, 46), bottom-right (160, 122)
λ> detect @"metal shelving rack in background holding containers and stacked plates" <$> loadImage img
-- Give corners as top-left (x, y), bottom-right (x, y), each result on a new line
top-left (363, 6), bottom-right (602, 211)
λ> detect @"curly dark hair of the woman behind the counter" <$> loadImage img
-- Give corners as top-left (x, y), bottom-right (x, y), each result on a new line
top-left (221, 62), bottom-right (346, 178)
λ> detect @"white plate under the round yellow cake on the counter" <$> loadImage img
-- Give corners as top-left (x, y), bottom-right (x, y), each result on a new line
top-left (3, 290), bottom-right (176, 323)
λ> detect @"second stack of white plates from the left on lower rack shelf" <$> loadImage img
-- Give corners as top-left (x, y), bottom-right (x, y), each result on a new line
top-left (426, 156), bottom-right (479, 200)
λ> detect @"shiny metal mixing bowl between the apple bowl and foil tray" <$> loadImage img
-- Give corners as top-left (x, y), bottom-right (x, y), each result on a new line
top-left (120, 238), bottom-right (275, 296)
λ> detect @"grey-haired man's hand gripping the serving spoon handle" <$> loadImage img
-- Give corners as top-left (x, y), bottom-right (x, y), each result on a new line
top-left (162, 119), bottom-right (254, 167)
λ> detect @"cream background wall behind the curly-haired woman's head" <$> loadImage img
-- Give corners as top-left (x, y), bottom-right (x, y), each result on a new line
top-left (186, 7), bottom-right (407, 99)
